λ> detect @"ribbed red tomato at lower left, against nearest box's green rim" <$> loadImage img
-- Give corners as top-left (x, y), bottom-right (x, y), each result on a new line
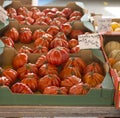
top-left (11, 82), bottom-right (33, 94)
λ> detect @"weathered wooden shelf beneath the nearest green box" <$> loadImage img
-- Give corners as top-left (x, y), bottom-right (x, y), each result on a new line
top-left (0, 106), bottom-right (120, 118)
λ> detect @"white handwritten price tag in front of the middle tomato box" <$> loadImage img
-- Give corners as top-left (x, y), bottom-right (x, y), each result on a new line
top-left (78, 33), bottom-right (101, 49)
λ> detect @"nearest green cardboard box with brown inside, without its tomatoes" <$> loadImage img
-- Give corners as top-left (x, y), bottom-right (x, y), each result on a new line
top-left (0, 49), bottom-right (114, 106)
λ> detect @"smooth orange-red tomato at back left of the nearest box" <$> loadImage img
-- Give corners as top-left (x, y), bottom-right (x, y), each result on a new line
top-left (12, 53), bottom-right (28, 69)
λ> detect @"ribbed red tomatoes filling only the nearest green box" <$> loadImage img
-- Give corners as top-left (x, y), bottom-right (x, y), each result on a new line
top-left (0, 51), bottom-right (104, 95)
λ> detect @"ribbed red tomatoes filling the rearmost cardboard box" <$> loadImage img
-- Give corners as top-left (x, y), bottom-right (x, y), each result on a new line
top-left (6, 6), bottom-right (83, 26)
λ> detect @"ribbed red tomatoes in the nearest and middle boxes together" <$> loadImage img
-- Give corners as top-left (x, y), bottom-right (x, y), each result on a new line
top-left (0, 23), bottom-right (105, 95)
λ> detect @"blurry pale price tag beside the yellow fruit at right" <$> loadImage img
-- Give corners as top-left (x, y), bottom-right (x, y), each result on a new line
top-left (98, 18), bottom-right (112, 32)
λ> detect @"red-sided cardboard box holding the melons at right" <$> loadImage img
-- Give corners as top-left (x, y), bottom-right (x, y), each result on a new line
top-left (103, 33), bottom-right (120, 109)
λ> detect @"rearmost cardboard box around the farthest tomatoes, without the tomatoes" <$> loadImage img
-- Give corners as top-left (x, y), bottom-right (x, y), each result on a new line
top-left (6, 0), bottom-right (95, 32)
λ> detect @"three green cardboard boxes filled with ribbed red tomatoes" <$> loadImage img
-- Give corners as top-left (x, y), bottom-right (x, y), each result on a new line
top-left (0, 1), bottom-right (117, 106)
